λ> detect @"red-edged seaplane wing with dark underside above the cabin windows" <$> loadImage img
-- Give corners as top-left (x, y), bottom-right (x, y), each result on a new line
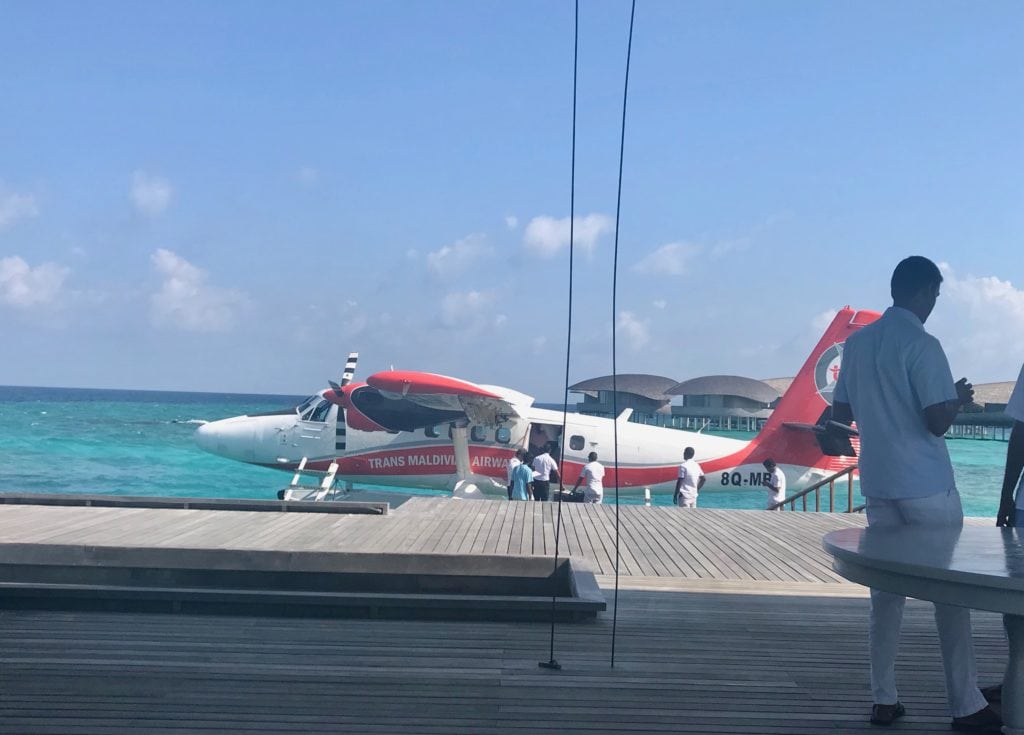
top-left (339, 371), bottom-right (534, 431)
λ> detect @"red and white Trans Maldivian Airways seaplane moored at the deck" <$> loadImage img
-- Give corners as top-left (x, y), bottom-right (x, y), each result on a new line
top-left (196, 306), bottom-right (880, 499)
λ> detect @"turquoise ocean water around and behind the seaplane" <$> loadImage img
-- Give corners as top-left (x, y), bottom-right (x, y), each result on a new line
top-left (0, 386), bottom-right (1007, 519)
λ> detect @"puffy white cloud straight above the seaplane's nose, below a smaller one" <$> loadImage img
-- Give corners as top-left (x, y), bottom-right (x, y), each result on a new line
top-left (150, 248), bottom-right (249, 332)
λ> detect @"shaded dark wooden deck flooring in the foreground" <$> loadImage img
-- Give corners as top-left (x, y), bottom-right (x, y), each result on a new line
top-left (0, 591), bottom-right (1006, 735)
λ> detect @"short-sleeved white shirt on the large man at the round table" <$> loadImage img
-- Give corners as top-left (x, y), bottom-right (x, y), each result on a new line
top-left (834, 306), bottom-right (956, 500)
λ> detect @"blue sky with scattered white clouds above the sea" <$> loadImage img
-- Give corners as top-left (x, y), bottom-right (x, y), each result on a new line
top-left (0, 0), bottom-right (1024, 400)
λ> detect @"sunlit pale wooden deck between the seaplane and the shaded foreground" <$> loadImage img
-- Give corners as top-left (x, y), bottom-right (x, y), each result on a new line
top-left (0, 498), bottom-right (864, 583)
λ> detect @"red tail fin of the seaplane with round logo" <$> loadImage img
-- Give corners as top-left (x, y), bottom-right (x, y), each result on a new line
top-left (752, 306), bottom-right (881, 471)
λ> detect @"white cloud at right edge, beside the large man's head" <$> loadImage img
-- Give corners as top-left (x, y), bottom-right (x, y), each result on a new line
top-left (928, 263), bottom-right (1024, 382)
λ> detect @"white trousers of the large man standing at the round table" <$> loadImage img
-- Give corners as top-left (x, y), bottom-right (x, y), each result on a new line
top-left (864, 487), bottom-right (987, 718)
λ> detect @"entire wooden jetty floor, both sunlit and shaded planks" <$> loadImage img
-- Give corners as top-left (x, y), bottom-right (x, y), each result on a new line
top-left (0, 499), bottom-right (1006, 735)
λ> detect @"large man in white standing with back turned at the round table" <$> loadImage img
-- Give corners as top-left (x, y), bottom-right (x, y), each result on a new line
top-left (834, 256), bottom-right (1002, 733)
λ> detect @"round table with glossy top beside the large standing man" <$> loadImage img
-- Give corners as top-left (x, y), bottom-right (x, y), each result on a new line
top-left (822, 526), bottom-right (1024, 735)
